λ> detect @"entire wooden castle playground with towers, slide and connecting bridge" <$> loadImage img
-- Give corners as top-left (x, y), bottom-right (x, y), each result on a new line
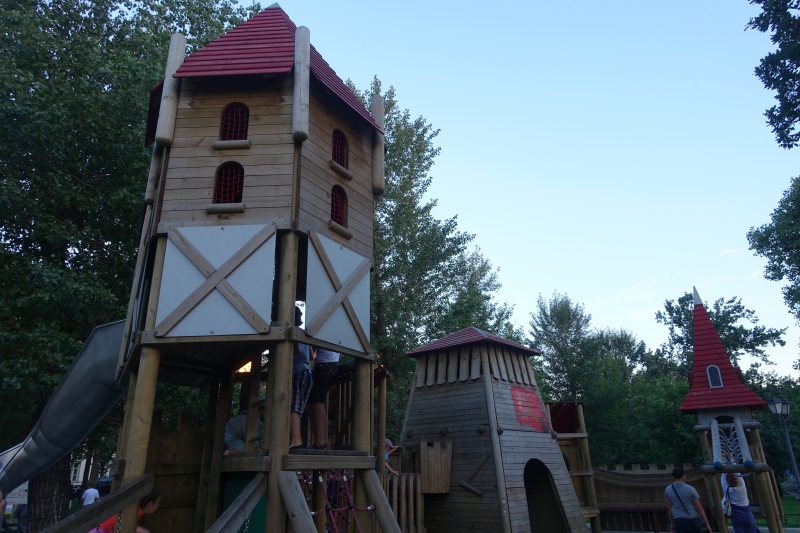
top-left (0, 5), bottom-right (782, 533)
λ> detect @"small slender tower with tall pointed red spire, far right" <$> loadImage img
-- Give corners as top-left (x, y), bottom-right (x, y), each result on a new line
top-left (680, 289), bottom-right (783, 533)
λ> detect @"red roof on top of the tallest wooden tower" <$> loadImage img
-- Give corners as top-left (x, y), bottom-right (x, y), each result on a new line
top-left (174, 4), bottom-right (380, 131)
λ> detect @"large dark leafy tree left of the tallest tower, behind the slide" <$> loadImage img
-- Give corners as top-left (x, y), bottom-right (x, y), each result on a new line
top-left (0, 0), bottom-right (250, 531)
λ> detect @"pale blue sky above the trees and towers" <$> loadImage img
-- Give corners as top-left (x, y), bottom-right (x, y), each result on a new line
top-left (280, 0), bottom-right (800, 375)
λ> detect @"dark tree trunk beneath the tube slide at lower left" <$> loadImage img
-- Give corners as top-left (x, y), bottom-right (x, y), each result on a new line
top-left (28, 454), bottom-right (72, 533)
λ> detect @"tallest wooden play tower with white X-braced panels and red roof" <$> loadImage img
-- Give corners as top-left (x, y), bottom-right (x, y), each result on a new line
top-left (112, 4), bottom-right (397, 533)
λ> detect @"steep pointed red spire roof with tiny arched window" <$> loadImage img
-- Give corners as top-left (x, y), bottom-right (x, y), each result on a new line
top-left (680, 288), bottom-right (767, 412)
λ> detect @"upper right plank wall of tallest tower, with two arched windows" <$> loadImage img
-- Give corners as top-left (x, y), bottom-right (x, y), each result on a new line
top-left (300, 79), bottom-right (374, 257)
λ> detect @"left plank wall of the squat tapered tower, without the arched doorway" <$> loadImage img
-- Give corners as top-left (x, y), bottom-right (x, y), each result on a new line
top-left (403, 347), bottom-right (501, 533)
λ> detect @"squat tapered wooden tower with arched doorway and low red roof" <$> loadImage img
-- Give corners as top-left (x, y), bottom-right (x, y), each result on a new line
top-left (402, 327), bottom-right (586, 533)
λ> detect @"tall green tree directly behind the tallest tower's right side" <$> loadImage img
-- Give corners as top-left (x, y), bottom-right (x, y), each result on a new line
top-left (348, 77), bottom-right (521, 437)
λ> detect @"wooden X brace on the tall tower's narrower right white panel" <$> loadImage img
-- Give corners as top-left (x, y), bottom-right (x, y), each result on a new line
top-left (306, 231), bottom-right (372, 352)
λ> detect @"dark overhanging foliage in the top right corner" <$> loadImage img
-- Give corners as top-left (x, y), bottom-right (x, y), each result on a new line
top-left (747, 0), bottom-right (800, 148)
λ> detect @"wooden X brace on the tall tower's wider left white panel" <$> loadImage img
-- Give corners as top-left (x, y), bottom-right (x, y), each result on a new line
top-left (155, 224), bottom-right (275, 337)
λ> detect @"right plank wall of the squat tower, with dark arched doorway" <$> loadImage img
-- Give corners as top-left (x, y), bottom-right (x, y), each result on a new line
top-left (488, 345), bottom-right (586, 533)
